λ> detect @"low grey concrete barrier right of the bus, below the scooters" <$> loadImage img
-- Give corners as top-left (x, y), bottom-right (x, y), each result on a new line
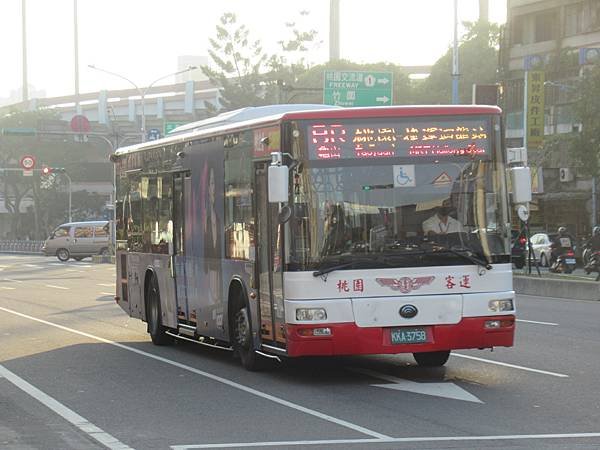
top-left (513, 276), bottom-right (600, 301)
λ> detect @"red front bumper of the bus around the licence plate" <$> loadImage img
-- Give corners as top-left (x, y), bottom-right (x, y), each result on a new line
top-left (287, 315), bottom-right (515, 357)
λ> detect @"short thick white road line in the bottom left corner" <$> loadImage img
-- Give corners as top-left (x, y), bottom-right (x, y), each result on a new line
top-left (0, 365), bottom-right (131, 450)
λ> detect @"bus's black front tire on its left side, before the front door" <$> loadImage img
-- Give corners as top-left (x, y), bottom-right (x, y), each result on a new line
top-left (230, 299), bottom-right (264, 371)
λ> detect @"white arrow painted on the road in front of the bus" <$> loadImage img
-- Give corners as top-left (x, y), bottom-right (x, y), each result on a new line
top-left (349, 368), bottom-right (483, 403)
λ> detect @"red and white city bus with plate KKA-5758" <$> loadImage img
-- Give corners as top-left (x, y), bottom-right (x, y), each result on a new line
top-left (112, 105), bottom-right (515, 369)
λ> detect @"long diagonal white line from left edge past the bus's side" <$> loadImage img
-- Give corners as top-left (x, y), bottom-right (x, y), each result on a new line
top-left (0, 306), bottom-right (390, 439)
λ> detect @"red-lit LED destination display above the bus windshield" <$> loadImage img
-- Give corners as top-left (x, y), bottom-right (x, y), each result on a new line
top-left (307, 118), bottom-right (489, 160)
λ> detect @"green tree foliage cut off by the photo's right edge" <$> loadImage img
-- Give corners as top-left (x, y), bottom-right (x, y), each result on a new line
top-left (571, 66), bottom-right (600, 176)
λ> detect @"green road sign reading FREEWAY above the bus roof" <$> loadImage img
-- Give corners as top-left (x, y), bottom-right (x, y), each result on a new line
top-left (323, 70), bottom-right (394, 106)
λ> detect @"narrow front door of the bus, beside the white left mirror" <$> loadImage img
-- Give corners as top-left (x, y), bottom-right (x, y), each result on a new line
top-left (254, 161), bottom-right (286, 344)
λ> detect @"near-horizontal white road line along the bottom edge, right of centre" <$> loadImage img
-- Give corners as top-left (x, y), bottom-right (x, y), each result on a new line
top-left (171, 433), bottom-right (600, 450)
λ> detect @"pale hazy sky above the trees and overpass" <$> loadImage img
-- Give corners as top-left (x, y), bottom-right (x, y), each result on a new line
top-left (0, 0), bottom-right (506, 100)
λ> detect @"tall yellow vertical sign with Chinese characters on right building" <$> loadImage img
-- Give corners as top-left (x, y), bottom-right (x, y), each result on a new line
top-left (525, 70), bottom-right (544, 149)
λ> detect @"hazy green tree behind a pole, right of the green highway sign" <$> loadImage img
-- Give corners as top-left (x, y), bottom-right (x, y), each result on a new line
top-left (415, 21), bottom-right (500, 104)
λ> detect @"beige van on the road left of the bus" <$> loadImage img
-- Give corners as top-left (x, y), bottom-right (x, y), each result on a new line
top-left (42, 220), bottom-right (110, 262)
